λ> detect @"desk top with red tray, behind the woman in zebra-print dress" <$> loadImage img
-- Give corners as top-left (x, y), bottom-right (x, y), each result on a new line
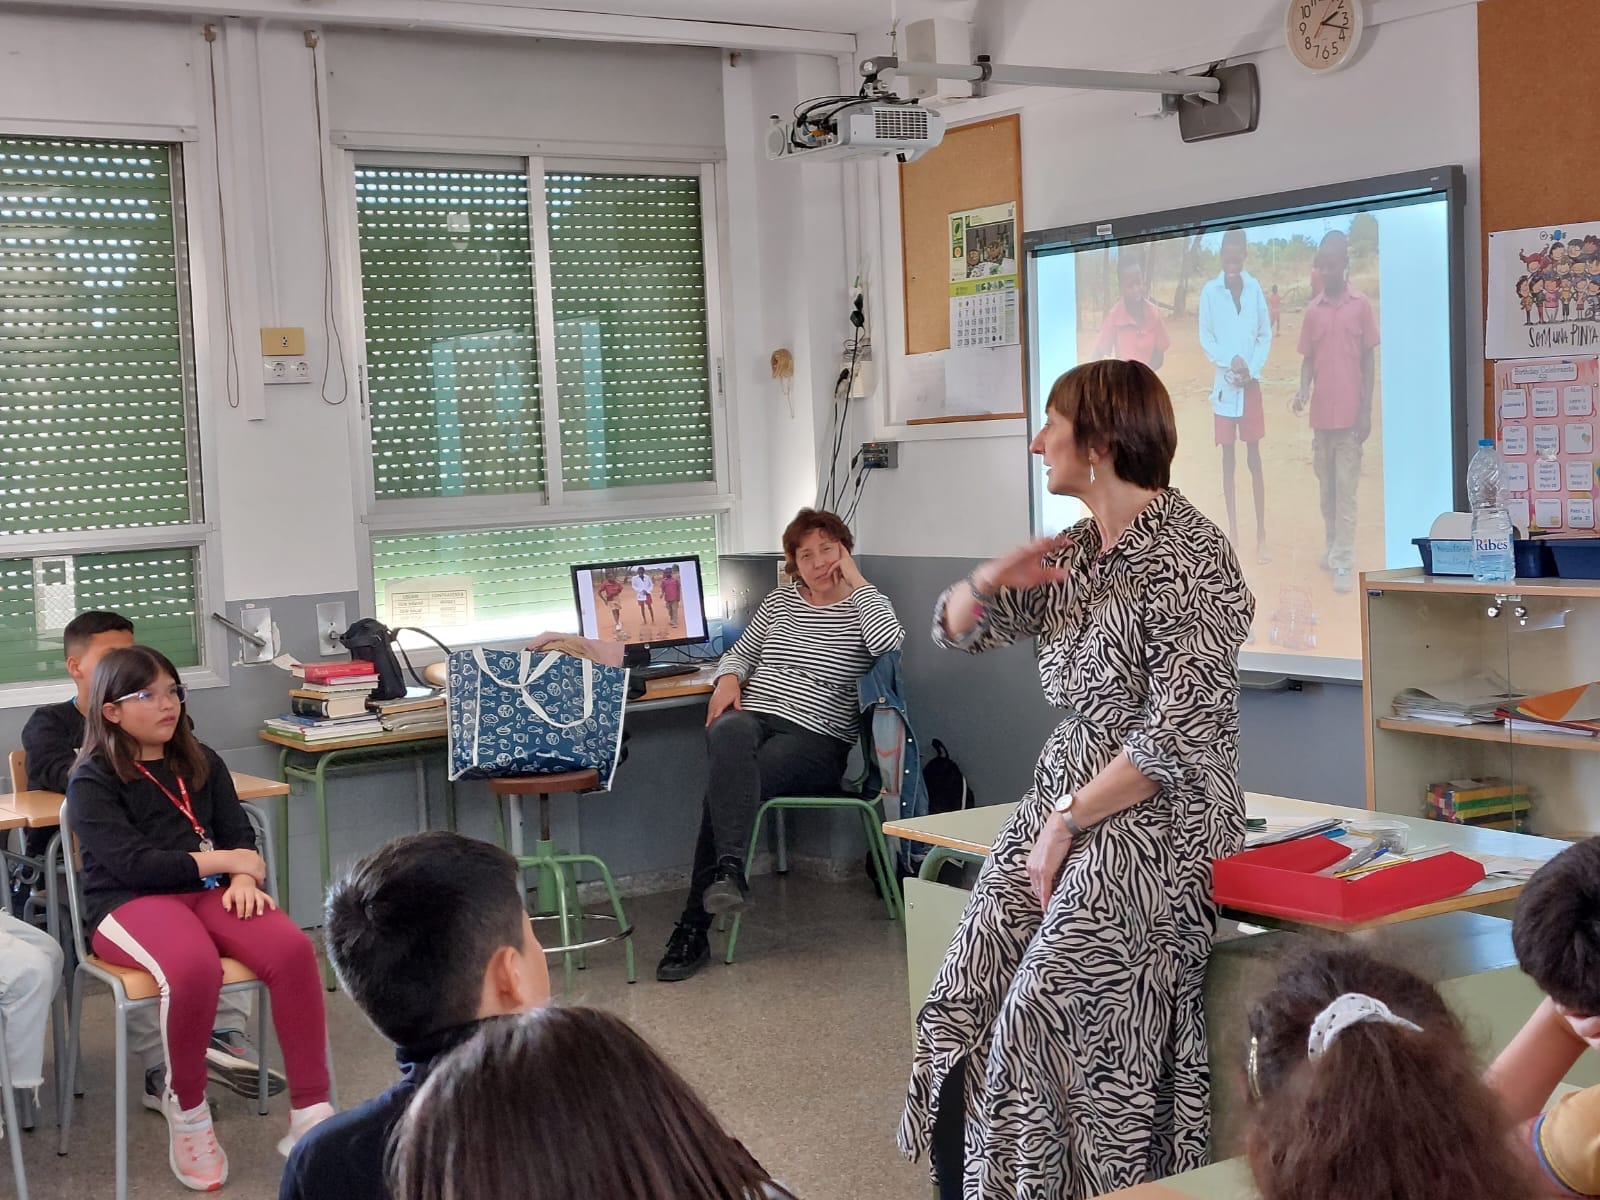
top-left (883, 792), bottom-right (1566, 933)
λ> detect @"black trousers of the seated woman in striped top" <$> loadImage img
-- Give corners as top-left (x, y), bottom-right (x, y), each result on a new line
top-left (683, 709), bottom-right (850, 926)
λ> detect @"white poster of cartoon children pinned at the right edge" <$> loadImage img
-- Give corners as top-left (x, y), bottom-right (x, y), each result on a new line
top-left (1483, 221), bottom-right (1600, 358)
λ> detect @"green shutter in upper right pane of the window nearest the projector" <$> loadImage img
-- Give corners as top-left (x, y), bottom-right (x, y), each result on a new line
top-left (544, 173), bottom-right (715, 491)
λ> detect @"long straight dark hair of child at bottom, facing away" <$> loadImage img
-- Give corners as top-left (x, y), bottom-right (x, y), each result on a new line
top-left (389, 1008), bottom-right (794, 1200)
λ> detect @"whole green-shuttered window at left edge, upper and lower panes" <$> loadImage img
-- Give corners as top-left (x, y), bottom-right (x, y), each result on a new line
top-left (0, 138), bottom-right (206, 685)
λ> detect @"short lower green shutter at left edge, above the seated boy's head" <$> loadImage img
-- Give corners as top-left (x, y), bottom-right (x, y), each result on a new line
top-left (0, 547), bottom-right (200, 683)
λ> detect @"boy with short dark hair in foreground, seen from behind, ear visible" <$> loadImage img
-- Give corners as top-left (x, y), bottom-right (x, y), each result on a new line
top-left (278, 832), bottom-right (550, 1200)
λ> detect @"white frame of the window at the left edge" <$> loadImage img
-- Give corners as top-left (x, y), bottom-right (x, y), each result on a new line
top-left (0, 120), bottom-right (229, 710)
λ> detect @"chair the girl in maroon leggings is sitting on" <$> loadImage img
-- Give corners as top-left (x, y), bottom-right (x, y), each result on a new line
top-left (51, 802), bottom-right (339, 1200)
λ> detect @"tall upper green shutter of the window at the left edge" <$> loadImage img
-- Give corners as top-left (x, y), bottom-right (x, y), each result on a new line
top-left (0, 138), bottom-right (200, 534)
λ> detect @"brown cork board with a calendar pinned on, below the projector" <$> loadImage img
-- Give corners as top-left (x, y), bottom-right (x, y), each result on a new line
top-left (899, 114), bottom-right (1027, 419)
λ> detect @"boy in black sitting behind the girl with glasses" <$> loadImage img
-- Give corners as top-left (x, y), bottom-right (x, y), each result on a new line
top-left (13, 611), bottom-right (283, 1112)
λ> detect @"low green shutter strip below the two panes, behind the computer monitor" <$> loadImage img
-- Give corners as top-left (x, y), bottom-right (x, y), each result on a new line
top-left (373, 517), bottom-right (717, 632)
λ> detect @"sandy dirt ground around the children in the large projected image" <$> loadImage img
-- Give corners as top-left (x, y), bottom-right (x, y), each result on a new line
top-left (1083, 293), bottom-right (1384, 659)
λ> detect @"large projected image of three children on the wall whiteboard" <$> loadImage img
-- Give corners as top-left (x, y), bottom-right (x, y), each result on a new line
top-left (1026, 168), bottom-right (1464, 678)
